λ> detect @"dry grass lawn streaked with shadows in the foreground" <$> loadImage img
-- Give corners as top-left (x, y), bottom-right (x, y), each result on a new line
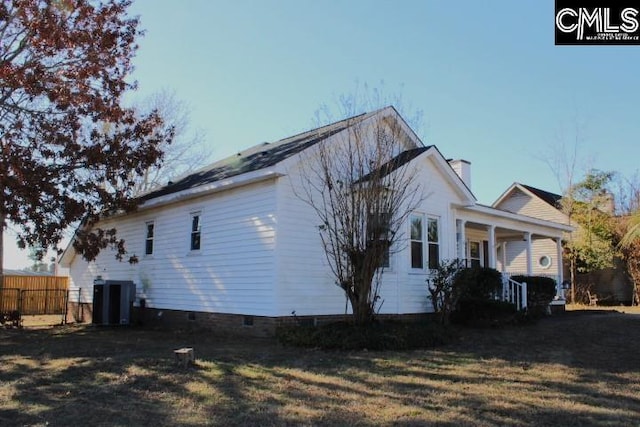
top-left (0, 310), bottom-right (640, 426)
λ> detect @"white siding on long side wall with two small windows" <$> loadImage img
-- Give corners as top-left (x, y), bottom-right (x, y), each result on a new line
top-left (70, 181), bottom-right (276, 316)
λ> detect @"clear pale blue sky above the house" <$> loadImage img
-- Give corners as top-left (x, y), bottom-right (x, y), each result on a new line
top-left (5, 0), bottom-right (640, 267)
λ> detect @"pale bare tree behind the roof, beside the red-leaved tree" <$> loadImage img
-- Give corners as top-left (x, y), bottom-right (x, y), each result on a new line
top-left (135, 90), bottom-right (211, 195)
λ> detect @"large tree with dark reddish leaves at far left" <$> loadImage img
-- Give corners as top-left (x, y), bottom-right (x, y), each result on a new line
top-left (0, 0), bottom-right (173, 272)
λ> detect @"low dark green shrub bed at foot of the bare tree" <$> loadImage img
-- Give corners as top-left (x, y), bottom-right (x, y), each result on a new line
top-left (276, 321), bottom-right (453, 350)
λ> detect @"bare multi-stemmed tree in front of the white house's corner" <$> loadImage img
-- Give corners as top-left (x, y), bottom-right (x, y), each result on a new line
top-left (296, 109), bottom-right (425, 324)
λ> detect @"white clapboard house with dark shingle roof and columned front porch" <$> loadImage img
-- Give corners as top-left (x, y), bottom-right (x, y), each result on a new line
top-left (61, 107), bottom-right (571, 331)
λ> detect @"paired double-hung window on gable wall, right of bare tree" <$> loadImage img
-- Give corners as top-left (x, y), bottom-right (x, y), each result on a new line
top-left (409, 214), bottom-right (440, 270)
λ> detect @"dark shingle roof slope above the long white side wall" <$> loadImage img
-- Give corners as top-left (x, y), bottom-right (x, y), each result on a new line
top-left (141, 110), bottom-right (380, 201)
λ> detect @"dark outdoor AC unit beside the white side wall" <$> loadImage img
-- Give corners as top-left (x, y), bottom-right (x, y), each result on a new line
top-left (92, 279), bottom-right (136, 325)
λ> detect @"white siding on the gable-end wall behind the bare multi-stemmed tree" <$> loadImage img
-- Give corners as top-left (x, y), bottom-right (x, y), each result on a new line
top-left (276, 152), bottom-right (458, 315)
